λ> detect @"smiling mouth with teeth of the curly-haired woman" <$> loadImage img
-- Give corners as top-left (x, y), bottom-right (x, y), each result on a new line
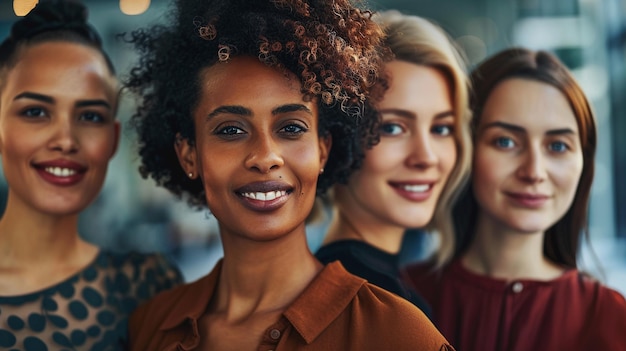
top-left (235, 181), bottom-right (293, 212)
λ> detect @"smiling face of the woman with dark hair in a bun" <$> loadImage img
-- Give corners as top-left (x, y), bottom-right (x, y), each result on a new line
top-left (0, 42), bottom-right (119, 215)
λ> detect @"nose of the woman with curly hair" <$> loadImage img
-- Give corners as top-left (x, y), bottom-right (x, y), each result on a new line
top-left (245, 134), bottom-right (285, 174)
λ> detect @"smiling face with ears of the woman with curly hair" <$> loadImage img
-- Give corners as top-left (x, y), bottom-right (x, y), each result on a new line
top-left (177, 57), bottom-right (329, 241)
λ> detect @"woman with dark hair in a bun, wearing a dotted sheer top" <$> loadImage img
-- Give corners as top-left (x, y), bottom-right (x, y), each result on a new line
top-left (0, 1), bottom-right (182, 351)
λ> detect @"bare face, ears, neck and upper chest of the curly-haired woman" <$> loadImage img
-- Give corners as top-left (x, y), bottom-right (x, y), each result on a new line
top-left (176, 57), bottom-right (330, 350)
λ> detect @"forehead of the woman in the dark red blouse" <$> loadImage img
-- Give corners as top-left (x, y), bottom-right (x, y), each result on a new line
top-left (479, 78), bottom-right (578, 131)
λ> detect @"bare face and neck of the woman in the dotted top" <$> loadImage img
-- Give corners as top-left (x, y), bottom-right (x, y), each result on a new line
top-left (0, 42), bottom-right (119, 296)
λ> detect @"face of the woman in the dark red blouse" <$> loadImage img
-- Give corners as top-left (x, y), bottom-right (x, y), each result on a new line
top-left (473, 78), bottom-right (583, 233)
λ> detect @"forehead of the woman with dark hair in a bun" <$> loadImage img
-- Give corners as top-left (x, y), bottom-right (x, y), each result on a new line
top-left (4, 42), bottom-right (117, 100)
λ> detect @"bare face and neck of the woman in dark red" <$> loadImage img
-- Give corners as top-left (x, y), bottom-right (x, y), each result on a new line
top-left (463, 78), bottom-right (583, 281)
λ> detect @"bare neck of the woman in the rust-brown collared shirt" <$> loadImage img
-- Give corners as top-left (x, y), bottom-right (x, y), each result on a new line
top-left (210, 224), bottom-right (322, 321)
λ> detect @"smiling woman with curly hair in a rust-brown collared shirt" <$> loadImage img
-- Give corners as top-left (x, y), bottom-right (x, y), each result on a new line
top-left (127, 0), bottom-right (451, 351)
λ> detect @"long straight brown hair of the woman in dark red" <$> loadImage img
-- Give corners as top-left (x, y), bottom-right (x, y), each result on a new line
top-left (455, 48), bottom-right (597, 268)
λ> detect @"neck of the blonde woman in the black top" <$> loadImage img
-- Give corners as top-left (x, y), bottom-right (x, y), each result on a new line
top-left (323, 208), bottom-right (405, 254)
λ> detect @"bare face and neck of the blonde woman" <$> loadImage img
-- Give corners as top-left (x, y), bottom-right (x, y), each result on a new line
top-left (324, 60), bottom-right (456, 253)
